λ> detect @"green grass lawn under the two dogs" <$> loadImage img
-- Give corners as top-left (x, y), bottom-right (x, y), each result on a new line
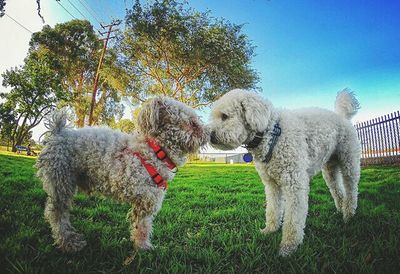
top-left (0, 152), bottom-right (400, 273)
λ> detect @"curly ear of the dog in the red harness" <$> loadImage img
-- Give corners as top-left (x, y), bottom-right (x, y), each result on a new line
top-left (138, 96), bottom-right (165, 135)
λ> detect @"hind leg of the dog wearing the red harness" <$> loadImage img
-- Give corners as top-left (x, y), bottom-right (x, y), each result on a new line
top-left (43, 171), bottom-right (86, 252)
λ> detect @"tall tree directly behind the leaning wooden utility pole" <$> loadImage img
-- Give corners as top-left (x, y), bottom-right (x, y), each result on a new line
top-left (29, 20), bottom-right (124, 127)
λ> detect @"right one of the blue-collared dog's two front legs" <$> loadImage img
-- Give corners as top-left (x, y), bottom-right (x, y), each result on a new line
top-left (279, 174), bottom-right (310, 256)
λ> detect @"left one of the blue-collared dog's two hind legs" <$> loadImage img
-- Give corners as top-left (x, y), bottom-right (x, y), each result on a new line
top-left (322, 161), bottom-right (344, 212)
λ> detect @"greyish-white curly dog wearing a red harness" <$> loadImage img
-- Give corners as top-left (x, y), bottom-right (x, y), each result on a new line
top-left (36, 97), bottom-right (209, 252)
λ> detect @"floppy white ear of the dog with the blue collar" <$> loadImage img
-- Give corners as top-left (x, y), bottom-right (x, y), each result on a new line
top-left (241, 94), bottom-right (272, 132)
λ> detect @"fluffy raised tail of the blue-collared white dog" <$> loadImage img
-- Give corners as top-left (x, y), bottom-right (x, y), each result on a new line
top-left (335, 88), bottom-right (360, 120)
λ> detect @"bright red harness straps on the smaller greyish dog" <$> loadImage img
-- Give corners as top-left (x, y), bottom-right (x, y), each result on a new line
top-left (127, 139), bottom-right (176, 190)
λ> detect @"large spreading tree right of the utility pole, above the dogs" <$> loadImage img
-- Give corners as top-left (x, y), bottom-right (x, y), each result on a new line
top-left (117, 0), bottom-right (258, 107)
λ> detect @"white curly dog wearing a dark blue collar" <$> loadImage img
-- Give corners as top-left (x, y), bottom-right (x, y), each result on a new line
top-left (211, 89), bottom-right (360, 256)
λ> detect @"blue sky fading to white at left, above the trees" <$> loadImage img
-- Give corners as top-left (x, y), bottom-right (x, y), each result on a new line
top-left (0, 0), bottom-right (400, 141)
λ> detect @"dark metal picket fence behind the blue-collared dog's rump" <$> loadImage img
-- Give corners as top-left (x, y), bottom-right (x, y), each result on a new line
top-left (355, 111), bottom-right (400, 165)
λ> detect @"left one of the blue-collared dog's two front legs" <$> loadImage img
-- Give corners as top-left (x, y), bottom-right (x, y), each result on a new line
top-left (261, 178), bottom-right (283, 234)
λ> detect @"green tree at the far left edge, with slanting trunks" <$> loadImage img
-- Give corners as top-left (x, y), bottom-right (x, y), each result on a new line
top-left (0, 51), bottom-right (65, 151)
